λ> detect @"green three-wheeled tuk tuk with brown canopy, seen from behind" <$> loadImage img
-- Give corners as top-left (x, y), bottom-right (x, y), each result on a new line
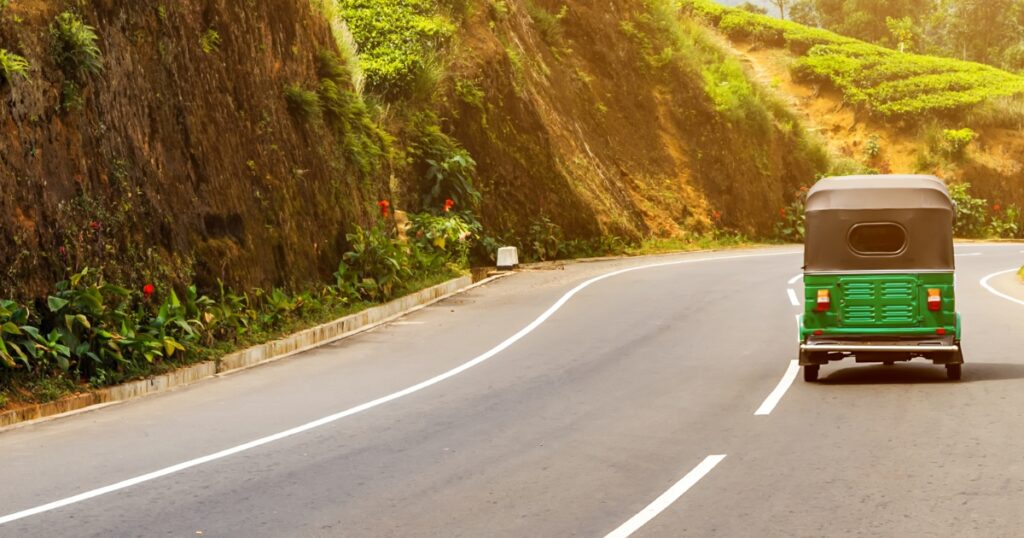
top-left (800, 175), bottom-right (964, 382)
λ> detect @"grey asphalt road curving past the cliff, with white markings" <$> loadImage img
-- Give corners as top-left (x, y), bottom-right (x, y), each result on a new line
top-left (0, 244), bottom-right (1024, 537)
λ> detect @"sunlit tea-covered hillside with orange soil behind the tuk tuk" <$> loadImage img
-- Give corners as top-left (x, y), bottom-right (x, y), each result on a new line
top-left (684, 0), bottom-right (1024, 235)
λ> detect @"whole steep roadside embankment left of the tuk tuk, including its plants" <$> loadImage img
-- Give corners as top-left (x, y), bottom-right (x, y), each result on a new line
top-left (0, 0), bottom-right (834, 397)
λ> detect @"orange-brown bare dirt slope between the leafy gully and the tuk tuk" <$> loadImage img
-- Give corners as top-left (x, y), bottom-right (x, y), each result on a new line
top-left (436, 0), bottom-right (822, 238)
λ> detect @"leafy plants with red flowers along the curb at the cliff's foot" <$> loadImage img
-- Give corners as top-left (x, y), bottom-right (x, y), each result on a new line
top-left (0, 212), bottom-right (478, 401)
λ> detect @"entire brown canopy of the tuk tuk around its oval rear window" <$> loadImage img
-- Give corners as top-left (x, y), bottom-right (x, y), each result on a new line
top-left (804, 175), bottom-right (955, 273)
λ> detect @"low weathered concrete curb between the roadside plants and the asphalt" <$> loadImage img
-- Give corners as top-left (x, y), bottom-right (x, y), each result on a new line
top-left (0, 273), bottom-right (511, 432)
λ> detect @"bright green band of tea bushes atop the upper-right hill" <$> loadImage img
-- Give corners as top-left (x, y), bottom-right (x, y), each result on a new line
top-left (681, 0), bottom-right (1024, 122)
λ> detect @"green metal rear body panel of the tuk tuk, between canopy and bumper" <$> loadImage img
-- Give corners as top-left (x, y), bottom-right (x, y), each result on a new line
top-left (801, 273), bottom-right (957, 340)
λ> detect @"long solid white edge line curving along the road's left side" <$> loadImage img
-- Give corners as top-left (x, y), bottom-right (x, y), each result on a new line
top-left (0, 252), bottom-right (796, 525)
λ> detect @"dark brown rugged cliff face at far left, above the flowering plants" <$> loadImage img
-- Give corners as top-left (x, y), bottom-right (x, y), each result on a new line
top-left (0, 0), bottom-right (386, 296)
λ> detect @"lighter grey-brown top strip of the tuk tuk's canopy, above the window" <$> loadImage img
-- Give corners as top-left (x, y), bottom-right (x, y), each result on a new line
top-left (807, 175), bottom-right (954, 212)
